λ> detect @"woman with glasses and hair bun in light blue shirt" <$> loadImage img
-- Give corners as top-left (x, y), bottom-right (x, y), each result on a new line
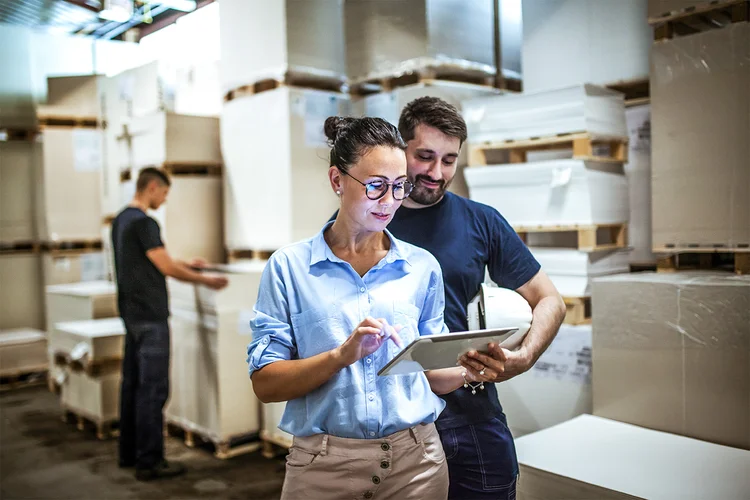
top-left (248, 117), bottom-right (494, 500)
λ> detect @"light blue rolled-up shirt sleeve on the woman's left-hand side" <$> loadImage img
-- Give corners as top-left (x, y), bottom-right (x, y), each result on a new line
top-left (247, 255), bottom-right (297, 377)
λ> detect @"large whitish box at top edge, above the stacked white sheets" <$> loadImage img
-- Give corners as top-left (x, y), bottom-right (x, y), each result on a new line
top-left (521, 0), bottom-right (653, 92)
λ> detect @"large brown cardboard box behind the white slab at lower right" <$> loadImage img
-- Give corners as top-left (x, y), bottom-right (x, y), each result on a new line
top-left (592, 272), bottom-right (750, 449)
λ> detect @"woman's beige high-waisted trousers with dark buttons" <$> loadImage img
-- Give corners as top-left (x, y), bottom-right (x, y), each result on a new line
top-left (281, 424), bottom-right (448, 500)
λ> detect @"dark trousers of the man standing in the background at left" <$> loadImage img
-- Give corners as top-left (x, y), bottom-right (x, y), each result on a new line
top-left (120, 321), bottom-right (169, 469)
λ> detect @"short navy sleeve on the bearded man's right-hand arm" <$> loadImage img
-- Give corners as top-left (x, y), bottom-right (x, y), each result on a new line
top-left (488, 211), bottom-right (541, 290)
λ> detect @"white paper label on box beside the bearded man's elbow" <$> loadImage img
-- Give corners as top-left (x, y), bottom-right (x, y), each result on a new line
top-left (532, 332), bottom-right (591, 384)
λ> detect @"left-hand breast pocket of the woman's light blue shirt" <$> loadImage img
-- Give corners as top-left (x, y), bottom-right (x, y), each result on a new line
top-left (292, 304), bottom-right (348, 358)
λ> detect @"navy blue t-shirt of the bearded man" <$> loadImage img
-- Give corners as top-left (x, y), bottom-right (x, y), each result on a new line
top-left (388, 193), bottom-right (540, 429)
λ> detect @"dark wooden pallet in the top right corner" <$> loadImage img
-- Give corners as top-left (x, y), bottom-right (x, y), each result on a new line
top-left (648, 0), bottom-right (750, 41)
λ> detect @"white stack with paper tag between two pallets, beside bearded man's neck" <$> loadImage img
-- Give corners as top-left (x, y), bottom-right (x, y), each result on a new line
top-left (464, 160), bottom-right (629, 226)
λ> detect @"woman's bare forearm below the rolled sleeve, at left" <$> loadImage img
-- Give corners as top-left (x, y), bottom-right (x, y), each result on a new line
top-left (251, 349), bottom-right (346, 403)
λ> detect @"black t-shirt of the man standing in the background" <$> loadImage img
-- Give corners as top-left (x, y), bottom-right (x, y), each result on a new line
top-left (112, 207), bottom-right (169, 321)
